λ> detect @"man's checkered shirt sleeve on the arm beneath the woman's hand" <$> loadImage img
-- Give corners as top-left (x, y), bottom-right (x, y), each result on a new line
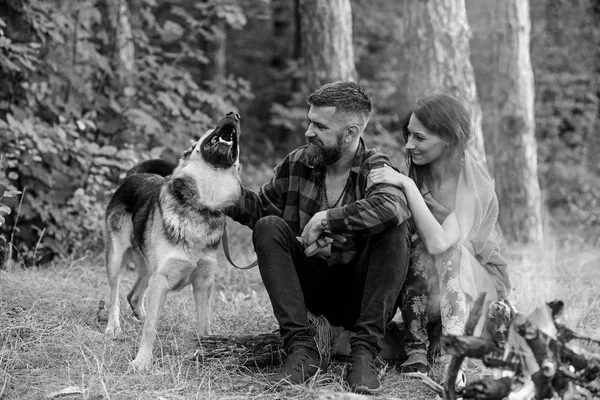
top-left (327, 153), bottom-right (411, 235)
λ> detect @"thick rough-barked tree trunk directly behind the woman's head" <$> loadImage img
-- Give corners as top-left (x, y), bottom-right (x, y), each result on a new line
top-left (399, 0), bottom-right (485, 161)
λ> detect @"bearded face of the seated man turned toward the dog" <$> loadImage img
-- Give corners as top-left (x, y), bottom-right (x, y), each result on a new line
top-left (305, 106), bottom-right (346, 168)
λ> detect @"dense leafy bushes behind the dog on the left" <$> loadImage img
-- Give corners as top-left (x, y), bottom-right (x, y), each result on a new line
top-left (0, 0), bottom-right (252, 263)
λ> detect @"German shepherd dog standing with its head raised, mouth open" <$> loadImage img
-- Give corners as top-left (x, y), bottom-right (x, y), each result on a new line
top-left (105, 112), bottom-right (241, 371)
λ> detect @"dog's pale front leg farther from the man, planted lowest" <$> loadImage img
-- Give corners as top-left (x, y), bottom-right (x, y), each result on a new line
top-left (131, 273), bottom-right (169, 372)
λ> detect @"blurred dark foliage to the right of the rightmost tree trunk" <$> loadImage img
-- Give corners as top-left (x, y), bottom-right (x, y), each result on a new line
top-left (531, 0), bottom-right (600, 234)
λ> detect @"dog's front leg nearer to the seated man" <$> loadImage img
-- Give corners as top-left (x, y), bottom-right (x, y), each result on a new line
top-left (192, 255), bottom-right (217, 336)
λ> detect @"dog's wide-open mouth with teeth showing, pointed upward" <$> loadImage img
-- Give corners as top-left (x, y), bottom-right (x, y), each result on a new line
top-left (201, 112), bottom-right (241, 168)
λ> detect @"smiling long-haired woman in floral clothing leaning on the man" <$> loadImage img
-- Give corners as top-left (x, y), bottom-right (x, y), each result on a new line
top-left (370, 95), bottom-right (510, 383)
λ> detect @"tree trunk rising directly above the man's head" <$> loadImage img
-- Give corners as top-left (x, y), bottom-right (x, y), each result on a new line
top-left (300, 0), bottom-right (356, 92)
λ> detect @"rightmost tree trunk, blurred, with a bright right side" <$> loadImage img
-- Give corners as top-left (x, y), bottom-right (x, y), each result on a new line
top-left (467, 0), bottom-right (542, 243)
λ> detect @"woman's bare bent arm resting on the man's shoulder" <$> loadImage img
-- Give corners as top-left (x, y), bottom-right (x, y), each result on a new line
top-left (369, 166), bottom-right (460, 255)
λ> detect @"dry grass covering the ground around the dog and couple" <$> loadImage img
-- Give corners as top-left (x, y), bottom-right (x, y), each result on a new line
top-left (0, 220), bottom-right (600, 400)
